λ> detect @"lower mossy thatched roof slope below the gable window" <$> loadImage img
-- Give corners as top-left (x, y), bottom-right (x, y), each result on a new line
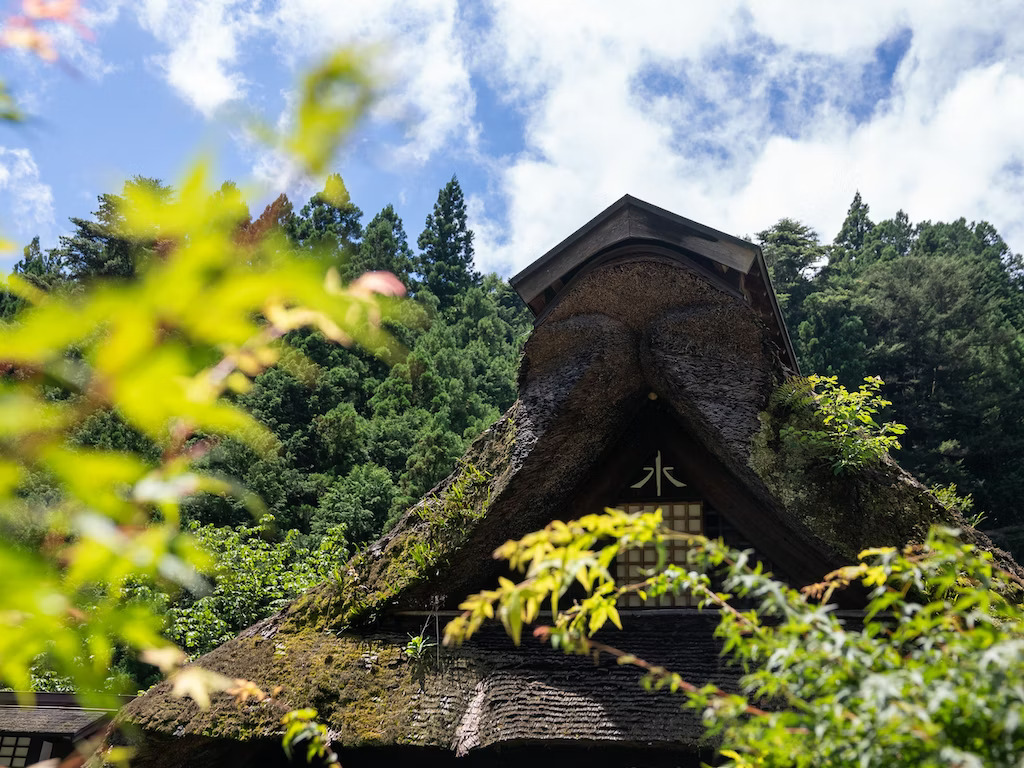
top-left (117, 610), bottom-right (737, 768)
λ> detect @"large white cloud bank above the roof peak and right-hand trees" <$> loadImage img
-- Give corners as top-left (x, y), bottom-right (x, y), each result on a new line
top-left (473, 0), bottom-right (1024, 271)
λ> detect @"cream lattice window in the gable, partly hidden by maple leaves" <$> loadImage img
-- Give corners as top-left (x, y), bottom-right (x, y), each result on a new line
top-left (615, 501), bottom-right (705, 608)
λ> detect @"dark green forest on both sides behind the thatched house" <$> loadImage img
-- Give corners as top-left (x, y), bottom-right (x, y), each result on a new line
top-left (0, 175), bottom-right (1024, 671)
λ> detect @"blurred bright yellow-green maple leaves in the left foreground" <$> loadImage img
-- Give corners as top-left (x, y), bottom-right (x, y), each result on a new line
top-left (0, 51), bottom-right (402, 708)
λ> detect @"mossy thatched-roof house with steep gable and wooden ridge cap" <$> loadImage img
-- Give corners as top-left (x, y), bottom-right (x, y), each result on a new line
top-left (122, 197), bottom-right (1016, 768)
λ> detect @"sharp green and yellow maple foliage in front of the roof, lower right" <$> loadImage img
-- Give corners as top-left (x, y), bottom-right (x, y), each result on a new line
top-left (445, 510), bottom-right (1024, 766)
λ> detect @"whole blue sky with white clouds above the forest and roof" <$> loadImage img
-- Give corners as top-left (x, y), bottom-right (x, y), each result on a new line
top-left (0, 0), bottom-right (1024, 274)
